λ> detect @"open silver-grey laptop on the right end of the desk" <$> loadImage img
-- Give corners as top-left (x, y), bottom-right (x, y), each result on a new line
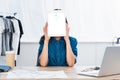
top-left (78, 46), bottom-right (120, 77)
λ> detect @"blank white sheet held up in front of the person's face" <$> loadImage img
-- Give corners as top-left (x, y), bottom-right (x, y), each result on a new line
top-left (48, 11), bottom-right (66, 36)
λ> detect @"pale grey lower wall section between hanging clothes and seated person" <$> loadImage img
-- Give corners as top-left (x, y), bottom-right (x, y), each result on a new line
top-left (17, 42), bottom-right (39, 66)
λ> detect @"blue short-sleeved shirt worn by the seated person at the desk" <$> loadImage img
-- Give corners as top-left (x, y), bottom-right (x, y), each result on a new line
top-left (37, 37), bottom-right (77, 66)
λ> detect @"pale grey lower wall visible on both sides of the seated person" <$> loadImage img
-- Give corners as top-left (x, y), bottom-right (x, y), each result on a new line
top-left (17, 42), bottom-right (111, 66)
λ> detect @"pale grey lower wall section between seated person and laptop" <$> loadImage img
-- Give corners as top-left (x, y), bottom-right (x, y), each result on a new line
top-left (77, 42), bottom-right (111, 66)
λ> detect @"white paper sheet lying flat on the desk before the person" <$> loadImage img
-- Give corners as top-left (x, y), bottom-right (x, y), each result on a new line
top-left (7, 70), bottom-right (67, 79)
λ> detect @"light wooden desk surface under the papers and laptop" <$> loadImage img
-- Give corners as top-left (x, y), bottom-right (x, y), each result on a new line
top-left (0, 67), bottom-right (120, 80)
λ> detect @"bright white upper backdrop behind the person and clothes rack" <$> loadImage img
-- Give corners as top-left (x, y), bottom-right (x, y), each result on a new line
top-left (0, 0), bottom-right (120, 42)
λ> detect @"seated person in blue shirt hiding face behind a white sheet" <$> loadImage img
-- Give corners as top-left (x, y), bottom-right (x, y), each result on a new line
top-left (37, 20), bottom-right (77, 67)
